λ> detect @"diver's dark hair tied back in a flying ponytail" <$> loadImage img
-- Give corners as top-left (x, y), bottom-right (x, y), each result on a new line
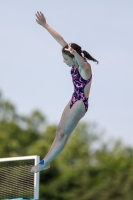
top-left (62, 43), bottom-right (98, 64)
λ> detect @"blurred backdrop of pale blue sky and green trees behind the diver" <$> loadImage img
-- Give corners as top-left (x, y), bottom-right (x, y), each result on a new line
top-left (0, 0), bottom-right (133, 200)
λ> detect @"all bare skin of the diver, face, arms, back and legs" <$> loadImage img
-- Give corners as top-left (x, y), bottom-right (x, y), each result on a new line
top-left (31, 12), bottom-right (91, 173)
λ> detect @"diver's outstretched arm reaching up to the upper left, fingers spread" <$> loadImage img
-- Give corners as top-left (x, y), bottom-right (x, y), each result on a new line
top-left (36, 12), bottom-right (67, 47)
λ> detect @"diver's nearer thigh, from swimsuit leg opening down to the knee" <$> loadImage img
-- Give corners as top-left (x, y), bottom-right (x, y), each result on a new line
top-left (58, 100), bottom-right (86, 135)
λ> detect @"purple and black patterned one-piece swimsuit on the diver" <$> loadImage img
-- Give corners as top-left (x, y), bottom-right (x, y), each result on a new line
top-left (70, 66), bottom-right (92, 112)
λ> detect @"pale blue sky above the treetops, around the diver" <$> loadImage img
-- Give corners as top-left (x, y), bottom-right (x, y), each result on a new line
top-left (0, 0), bottom-right (133, 146)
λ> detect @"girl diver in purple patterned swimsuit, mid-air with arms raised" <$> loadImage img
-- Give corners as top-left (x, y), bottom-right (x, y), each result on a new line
top-left (31, 12), bottom-right (98, 173)
